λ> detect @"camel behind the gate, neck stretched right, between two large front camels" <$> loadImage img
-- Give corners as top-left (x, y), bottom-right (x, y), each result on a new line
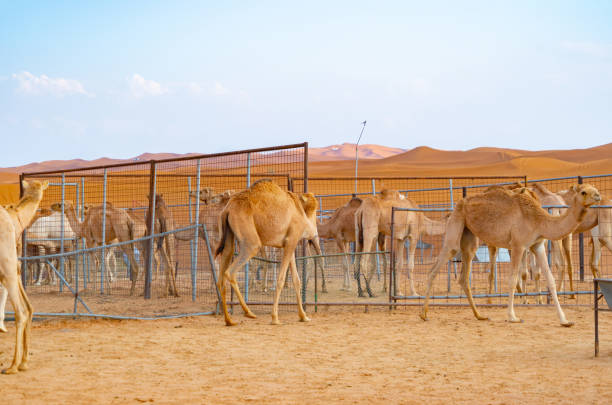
top-left (355, 190), bottom-right (446, 297)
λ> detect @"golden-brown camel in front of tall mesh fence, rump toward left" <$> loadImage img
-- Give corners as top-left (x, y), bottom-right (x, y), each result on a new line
top-left (216, 180), bottom-right (321, 326)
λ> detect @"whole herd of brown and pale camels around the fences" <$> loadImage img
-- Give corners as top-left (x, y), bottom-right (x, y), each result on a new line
top-left (0, 180), bottom-right (612, 373)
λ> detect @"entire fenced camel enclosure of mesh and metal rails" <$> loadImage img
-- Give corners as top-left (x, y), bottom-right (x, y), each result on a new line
top-left (10, 158), bottom-right (612, 316)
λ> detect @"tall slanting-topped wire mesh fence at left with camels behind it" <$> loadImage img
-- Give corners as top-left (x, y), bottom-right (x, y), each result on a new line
top-left (21, 143), bottom-right (308, 317)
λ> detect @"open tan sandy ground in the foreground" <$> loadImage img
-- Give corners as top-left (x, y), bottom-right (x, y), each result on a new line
top-left (0, 307), bottom-right (612, 404)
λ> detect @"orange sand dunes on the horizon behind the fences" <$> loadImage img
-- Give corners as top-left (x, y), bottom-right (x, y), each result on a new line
top-left (0, 143), bottom-right (612, 203)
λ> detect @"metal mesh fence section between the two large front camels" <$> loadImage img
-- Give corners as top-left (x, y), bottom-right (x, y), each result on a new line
top-left (293, 176), bottom-right (527, 305)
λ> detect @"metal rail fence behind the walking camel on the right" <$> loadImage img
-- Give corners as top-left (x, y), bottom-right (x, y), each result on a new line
top-left (389, 175), bottom-right (612, 305)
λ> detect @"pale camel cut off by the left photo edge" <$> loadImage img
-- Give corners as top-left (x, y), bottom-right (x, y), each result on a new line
top-left (0, 180), bottom-right (49, 374)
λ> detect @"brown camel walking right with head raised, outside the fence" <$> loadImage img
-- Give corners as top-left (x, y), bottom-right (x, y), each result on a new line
top-left (420, 184), bottom-right (601, 326)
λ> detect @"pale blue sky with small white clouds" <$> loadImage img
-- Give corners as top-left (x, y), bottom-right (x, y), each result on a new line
top-left (0, 0), bottom-right (612, 167)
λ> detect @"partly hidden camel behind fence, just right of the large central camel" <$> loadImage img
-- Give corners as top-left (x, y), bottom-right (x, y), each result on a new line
top-left (317, 197), bottom-right (387, 292)
